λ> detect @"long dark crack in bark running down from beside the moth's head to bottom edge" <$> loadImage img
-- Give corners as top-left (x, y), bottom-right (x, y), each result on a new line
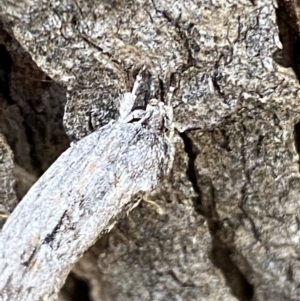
top-left (180, 133), bottom-right (254, 301)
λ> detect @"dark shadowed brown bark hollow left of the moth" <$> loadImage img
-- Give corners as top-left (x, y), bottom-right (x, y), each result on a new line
top-left (0, 24), bottom-right (69, 218)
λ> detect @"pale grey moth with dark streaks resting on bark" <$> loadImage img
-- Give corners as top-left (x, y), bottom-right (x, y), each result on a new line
top-left (0, 67), bottom-right (174, 301)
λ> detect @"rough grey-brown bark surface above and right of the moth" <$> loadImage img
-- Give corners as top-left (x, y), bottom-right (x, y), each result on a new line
top-left (2, 0), bottom-right (300, 301)
